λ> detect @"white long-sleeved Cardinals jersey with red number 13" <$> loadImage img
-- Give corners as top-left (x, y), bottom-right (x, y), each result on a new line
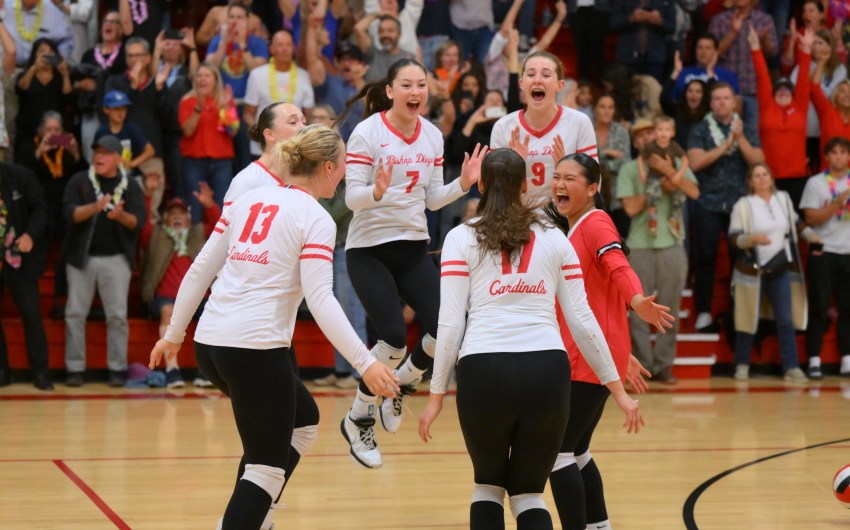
top-left (165, 186), bottom-right (375, 373)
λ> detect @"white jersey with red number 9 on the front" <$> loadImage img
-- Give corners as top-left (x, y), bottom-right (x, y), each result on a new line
top-left (490, 105), bottom-right (599, 200)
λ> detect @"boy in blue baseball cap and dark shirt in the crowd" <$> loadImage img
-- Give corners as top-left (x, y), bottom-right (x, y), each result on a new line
top-left (94, 90), bottom-right (154, 174)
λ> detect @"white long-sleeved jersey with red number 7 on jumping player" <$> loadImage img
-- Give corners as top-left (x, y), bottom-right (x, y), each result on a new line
top-left (345, 112), bottom-right (464, 249)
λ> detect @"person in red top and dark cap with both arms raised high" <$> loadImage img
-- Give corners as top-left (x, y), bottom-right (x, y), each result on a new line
top-left (747, 27), bottom-right (815, 207)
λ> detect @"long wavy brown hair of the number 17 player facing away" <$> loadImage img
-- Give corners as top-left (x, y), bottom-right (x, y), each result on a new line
top-left (469, 148), bottom-right (538, 258)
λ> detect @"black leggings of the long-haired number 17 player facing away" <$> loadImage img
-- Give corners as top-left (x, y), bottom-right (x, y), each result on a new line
top-left (457, 350), bottom-right (570, 496)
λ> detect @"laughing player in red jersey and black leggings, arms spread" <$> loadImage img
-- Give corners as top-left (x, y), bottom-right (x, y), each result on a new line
top-left (548, 154), bottom-right (674, 530)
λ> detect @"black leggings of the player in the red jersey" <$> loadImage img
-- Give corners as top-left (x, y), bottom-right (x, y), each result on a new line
top-left (550, 381), bottom-right (611, 530)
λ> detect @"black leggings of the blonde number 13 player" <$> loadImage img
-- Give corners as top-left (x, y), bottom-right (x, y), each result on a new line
top-left (195, 342), bottom-right (319, 528)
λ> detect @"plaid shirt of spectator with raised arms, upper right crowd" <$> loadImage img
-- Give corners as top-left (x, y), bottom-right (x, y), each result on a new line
top-left (708, 9), bottom-right (778, 96)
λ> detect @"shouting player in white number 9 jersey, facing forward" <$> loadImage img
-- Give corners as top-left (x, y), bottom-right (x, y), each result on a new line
top-left (490, 52), bottom-right (598, 201)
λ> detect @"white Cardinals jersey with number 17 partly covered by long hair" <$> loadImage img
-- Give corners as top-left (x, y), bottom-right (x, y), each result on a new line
top-left (431, 220), bottom-right (619, 394)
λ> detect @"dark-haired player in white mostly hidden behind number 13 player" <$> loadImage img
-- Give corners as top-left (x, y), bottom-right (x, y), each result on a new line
top-left (224, 103), bottom-right (307, 203)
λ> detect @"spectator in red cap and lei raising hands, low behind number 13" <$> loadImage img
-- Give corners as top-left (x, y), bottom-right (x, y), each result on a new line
top-left (141, 179), bottom-right (221, 388)
